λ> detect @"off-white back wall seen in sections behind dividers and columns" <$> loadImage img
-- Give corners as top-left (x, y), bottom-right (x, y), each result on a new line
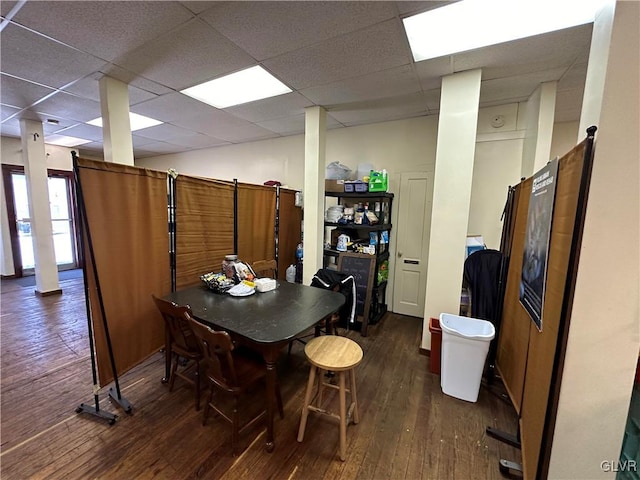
top-left (1, 109), bottom-right (577, 286)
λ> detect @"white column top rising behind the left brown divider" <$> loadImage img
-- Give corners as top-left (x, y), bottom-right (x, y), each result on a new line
top-left (100, 76), bottom-right (134, 165)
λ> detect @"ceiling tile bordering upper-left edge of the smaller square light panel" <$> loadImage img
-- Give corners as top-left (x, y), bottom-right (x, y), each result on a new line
top-left (118, 19), bottom-right (256, 90)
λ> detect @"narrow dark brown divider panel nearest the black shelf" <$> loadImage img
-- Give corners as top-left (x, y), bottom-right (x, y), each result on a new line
top-left (278, 188), bottom-right (302, 280)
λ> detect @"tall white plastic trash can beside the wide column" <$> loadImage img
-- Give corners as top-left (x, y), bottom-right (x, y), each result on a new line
top-left (440, 313), bottom-right (496, 402)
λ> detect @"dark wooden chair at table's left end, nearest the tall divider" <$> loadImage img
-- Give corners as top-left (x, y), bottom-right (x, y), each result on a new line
top-left (151, 294), bottom-right (203, 410)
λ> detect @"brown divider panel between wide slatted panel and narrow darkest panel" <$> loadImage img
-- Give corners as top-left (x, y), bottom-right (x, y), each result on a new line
top-left (237, 183), bottom-right (276, 264)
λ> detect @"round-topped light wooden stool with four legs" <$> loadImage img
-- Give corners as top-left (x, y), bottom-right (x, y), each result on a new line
top-left (298, 335), bottom-right (363, 461)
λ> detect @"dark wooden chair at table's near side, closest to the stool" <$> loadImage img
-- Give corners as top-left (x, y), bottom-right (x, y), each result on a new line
top-left (184, 312), bottom-right (284, 455)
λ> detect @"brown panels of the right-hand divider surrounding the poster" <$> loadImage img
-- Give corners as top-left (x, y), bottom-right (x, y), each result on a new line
top-left (497, 141), bottom-right (587, 479)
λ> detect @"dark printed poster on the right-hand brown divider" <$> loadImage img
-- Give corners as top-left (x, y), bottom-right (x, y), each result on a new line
top-left (520, 159), bottom-right (558, 331)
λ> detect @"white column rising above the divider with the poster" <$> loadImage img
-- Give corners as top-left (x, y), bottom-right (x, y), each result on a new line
top-left (520, 82), bottom-right (558, 178)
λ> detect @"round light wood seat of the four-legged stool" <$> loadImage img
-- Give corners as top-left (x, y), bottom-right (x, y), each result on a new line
top-left (304, 335), bottom-right (363, 372)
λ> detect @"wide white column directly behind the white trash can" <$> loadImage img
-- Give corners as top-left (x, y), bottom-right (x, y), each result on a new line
top-left (422, 70), bottom-right (482, 349)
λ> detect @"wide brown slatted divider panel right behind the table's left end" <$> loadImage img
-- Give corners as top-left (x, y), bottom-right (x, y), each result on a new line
top-left (174, 175), bottom-right (234, 288)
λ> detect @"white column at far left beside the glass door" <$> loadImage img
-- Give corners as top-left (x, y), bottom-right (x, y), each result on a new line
top-left (20, 120), bottom-right (62, 295)
